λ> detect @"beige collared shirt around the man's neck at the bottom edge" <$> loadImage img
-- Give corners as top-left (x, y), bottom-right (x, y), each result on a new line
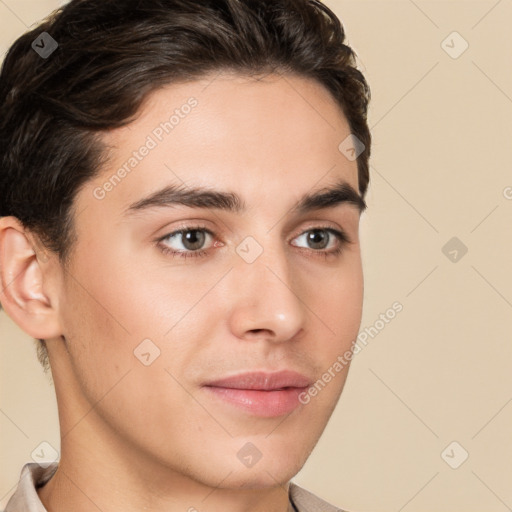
top-left (4, 462), bottom-right (345, 512)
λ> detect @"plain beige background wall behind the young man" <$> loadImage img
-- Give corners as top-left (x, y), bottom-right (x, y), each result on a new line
top-left (0, 0), bottom-right (512, 512)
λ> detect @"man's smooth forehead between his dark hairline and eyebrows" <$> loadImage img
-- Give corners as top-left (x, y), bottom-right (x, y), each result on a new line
top-left (81, 73), bottom-right (358, 220)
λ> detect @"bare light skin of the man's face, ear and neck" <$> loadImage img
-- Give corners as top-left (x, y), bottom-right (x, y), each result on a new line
top-left (0, 74), bottom-right (363, 512)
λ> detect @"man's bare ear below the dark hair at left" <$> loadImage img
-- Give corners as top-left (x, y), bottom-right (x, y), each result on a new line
top-left (0, 216), bottom-right (61, 339)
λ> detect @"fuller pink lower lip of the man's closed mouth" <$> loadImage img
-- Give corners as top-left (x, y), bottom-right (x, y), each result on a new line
top-left (204, 386), bottom-right (307, 418)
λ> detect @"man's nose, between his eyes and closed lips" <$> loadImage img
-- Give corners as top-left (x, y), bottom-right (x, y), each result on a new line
top-left (229, 239), bottom-right (307, 342)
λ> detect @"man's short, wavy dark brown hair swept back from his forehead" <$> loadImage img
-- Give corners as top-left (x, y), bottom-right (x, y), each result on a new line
top-left (0, 0), bottom-right (371, 370)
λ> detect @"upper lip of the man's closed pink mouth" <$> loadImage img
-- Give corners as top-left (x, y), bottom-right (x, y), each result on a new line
top-left (204, 370), bottom-right (311, 391)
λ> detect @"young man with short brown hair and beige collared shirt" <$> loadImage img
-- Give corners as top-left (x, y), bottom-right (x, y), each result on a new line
top-left (0, 0), bottom-right (370, 512)
